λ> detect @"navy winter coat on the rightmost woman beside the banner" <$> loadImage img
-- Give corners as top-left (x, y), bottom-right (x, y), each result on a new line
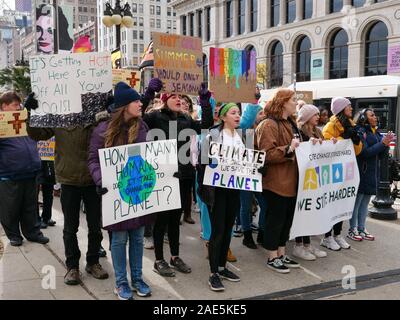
top-left (357, 125), bottom-right (388, 195)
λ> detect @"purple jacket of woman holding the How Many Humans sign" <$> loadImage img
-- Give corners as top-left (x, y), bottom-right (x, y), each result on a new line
top-left (88, 116), bottom-right (154, 231)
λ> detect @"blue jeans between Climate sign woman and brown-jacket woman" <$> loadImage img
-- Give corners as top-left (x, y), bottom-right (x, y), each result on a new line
top-left (240, 191), bottom-right (267, 231)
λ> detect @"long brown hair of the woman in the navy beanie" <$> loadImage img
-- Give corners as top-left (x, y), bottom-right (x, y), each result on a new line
top-left (104, 107), bottom-right (139, 148)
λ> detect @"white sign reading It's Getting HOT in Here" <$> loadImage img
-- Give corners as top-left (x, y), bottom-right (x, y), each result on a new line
top-left (29, 52), bottom-right (112, 116)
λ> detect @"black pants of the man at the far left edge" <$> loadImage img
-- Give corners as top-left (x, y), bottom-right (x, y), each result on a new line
top-left (0, 178), bottom-right (42, 240)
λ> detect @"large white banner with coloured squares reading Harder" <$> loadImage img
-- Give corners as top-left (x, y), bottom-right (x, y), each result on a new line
top-left (290, 140), bottom-right (360, 239)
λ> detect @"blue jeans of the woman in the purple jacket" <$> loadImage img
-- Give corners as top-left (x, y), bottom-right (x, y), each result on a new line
top-left (111, 226), bottom-right (144, 287)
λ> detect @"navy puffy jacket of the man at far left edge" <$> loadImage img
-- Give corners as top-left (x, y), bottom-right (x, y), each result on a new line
top-left (0, 137), bottom-right (41, 180)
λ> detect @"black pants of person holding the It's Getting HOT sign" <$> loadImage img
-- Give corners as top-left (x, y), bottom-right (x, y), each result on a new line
top-left (61, 184), bottom-right (103, 270)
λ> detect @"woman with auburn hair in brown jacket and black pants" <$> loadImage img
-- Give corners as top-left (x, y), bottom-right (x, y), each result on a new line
top-left (256, 89), bottom-right (301, 273)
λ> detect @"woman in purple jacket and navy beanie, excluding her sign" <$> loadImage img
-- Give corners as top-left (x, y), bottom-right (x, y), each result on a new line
top-left (89, 82), bottom-right (153, 300)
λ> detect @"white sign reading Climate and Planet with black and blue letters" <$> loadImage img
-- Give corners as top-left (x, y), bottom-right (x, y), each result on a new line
top-left (203, 142), bottom-right (265, 192)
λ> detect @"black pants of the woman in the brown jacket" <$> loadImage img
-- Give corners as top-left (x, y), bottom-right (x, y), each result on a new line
top-left (263, 190), bottom-right (296, 251)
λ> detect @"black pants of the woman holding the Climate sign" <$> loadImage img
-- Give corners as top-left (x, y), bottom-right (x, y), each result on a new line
top-left (208, 188), bottom-right (240, 273)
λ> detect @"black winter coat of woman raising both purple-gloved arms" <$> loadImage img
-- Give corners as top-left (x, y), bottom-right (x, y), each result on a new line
top-left (143, 104), bottom-right (213, 179)
